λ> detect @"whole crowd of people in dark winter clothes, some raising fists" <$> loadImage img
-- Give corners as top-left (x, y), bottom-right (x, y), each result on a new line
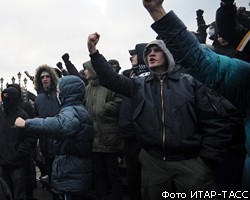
top-left (0, 0), bottom-right (250, 200)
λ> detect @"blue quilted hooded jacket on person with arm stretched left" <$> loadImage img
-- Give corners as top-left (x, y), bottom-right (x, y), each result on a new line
top-left (26, 75), bottom-right (94, 193)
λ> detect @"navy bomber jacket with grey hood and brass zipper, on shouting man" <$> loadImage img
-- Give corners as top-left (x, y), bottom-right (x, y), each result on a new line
top-left (90, 40), bottom-right (231, 165)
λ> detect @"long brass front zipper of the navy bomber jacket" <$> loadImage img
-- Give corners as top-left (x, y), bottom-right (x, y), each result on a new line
top-left (160, 78), bottom-right (166, 160)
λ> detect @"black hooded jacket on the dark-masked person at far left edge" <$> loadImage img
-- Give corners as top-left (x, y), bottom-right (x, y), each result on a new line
top-left (0, 87), bottom-right (36, 168)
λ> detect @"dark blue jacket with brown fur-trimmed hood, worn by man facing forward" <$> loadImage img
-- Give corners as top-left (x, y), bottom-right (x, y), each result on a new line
top-left (34, 65), bottom-right (60, 159)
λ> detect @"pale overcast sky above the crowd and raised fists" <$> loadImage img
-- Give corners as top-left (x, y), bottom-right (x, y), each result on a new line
top-left (0, 0), bottom-right (250, 92)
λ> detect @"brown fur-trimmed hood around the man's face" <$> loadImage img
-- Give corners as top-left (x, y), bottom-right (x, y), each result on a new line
top-left (34, 65), bottom-right (58, 91)
